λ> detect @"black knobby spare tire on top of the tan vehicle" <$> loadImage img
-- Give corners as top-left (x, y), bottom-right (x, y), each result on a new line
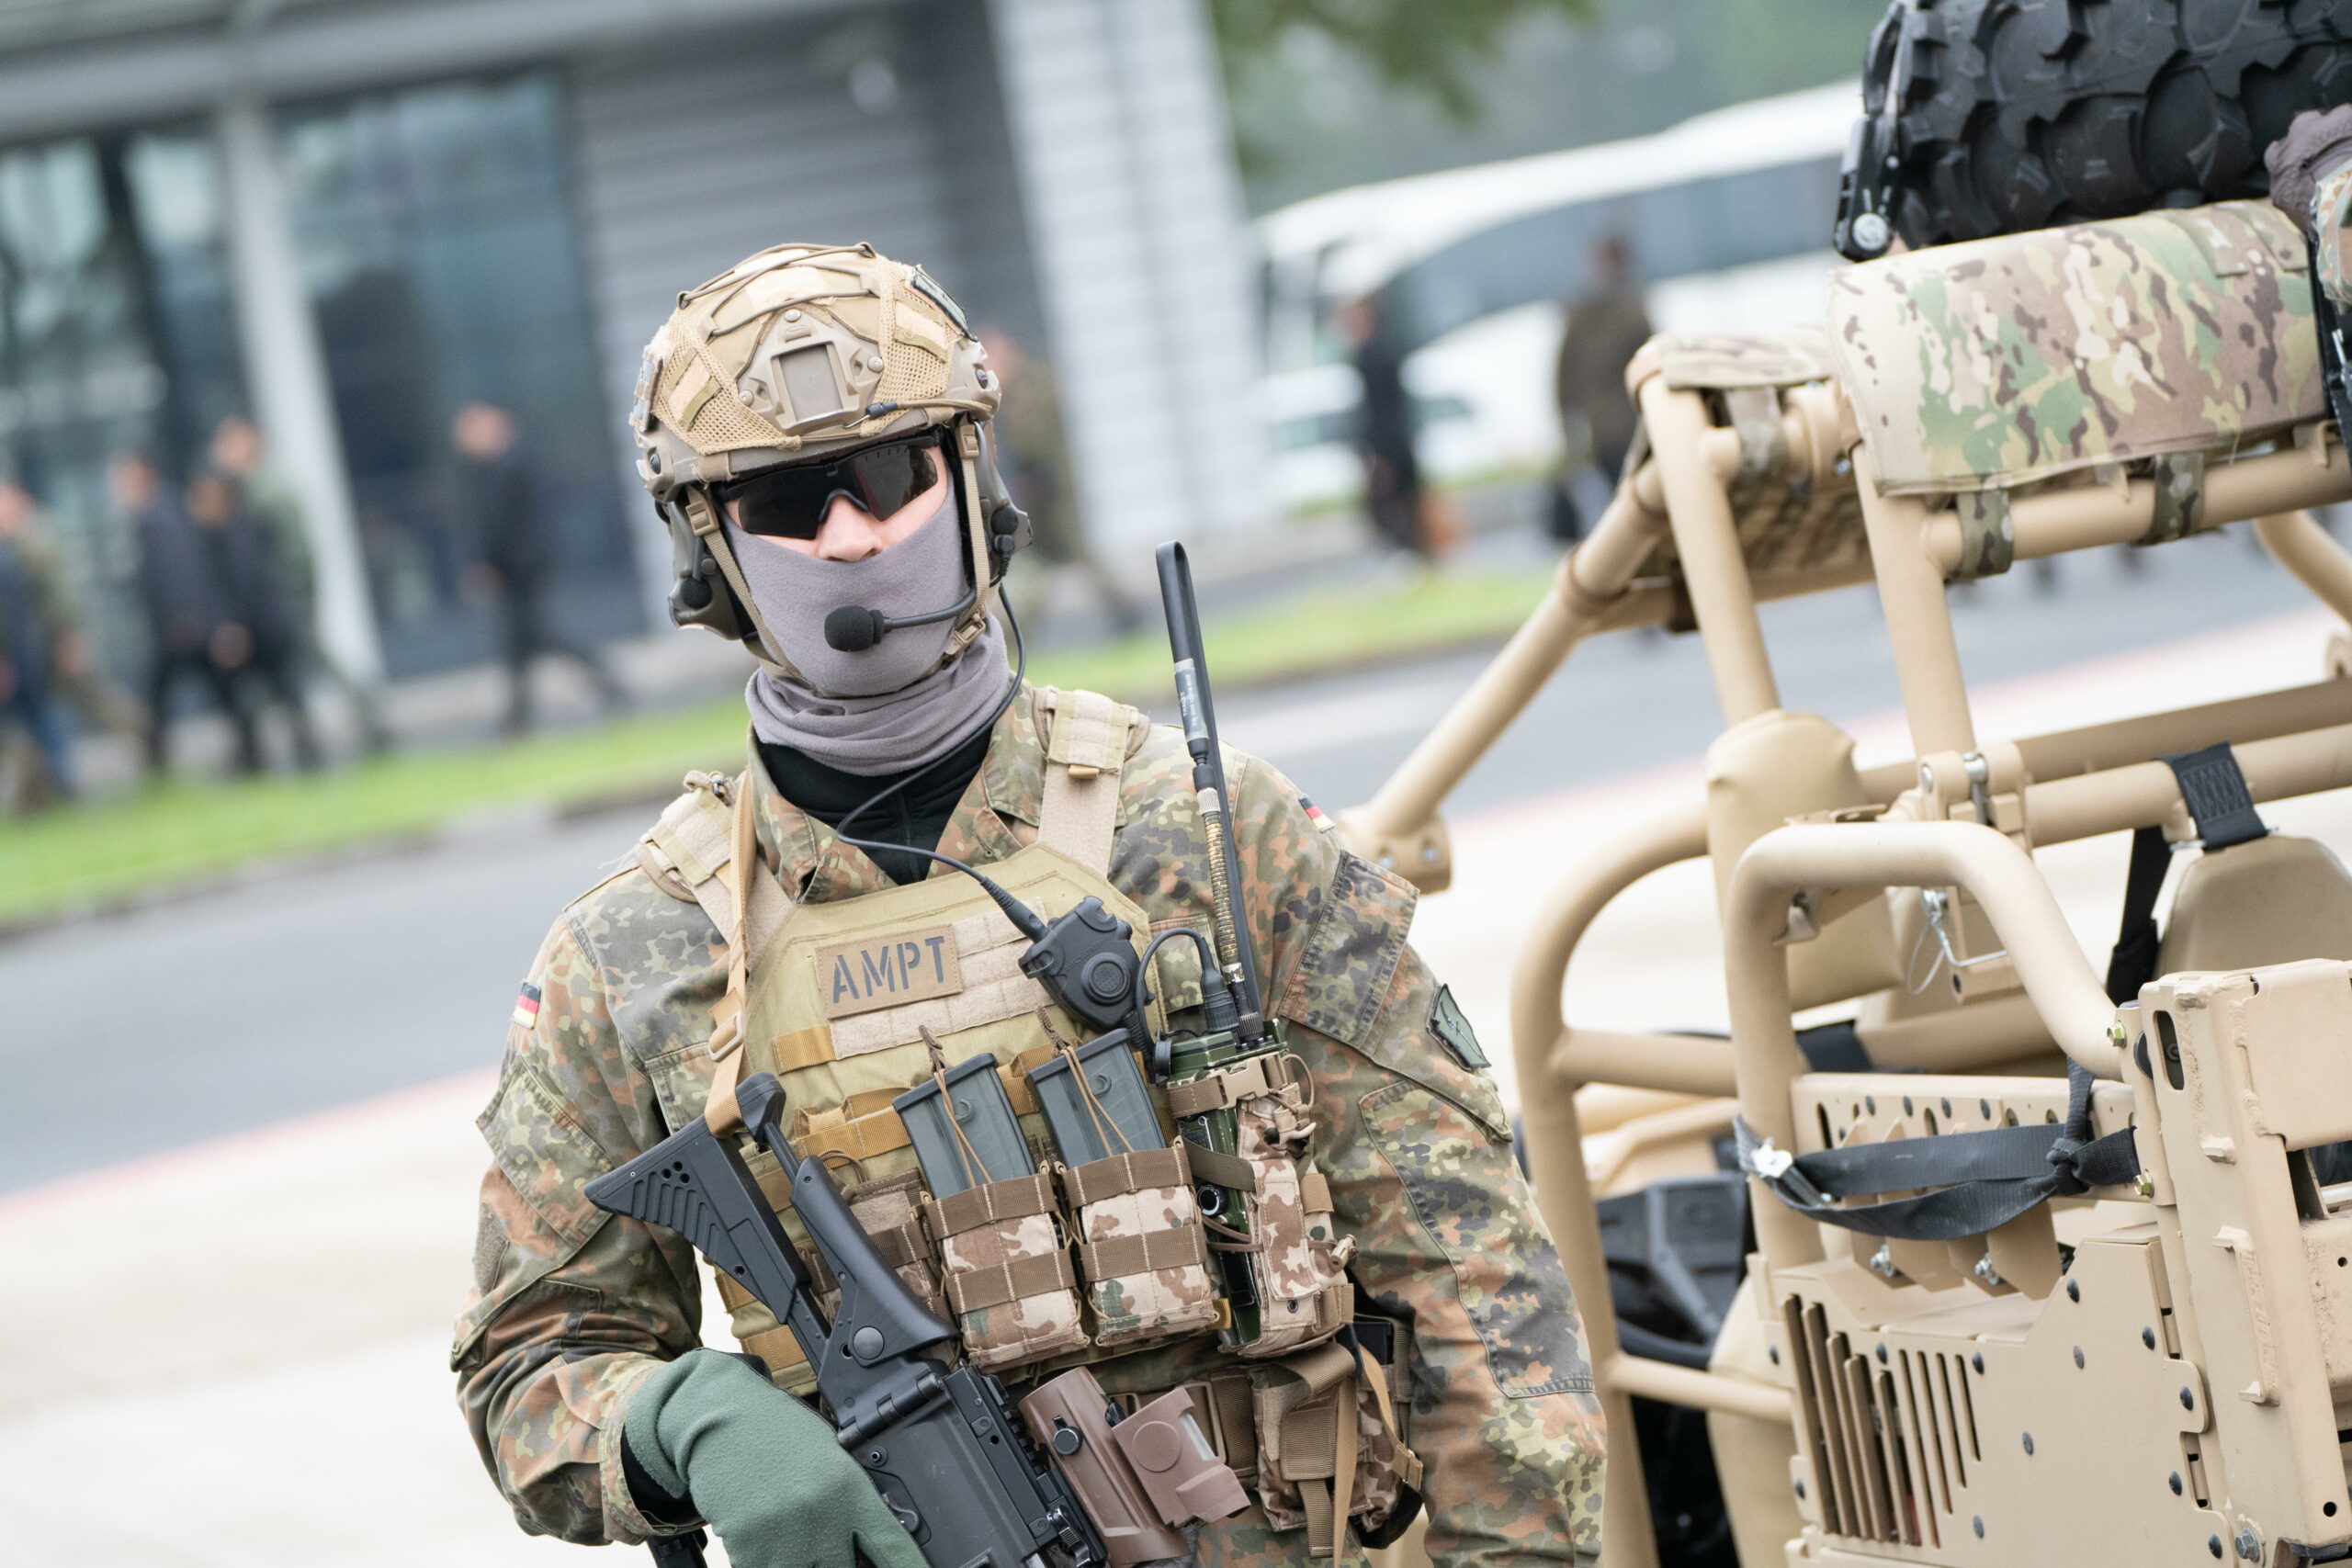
top-left (1835, 0), bottom-right (2352, 261)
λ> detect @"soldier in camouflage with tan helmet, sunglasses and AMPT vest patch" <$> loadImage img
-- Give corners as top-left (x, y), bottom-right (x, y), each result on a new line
top-left (452, 244), bottom-right (1601, 1568)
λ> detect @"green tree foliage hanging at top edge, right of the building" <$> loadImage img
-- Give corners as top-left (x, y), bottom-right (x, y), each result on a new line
top-left (1209, 0), bottom-right (1600, 125)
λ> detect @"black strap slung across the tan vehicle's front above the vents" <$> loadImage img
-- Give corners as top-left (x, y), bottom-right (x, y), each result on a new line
top-left (1734, 1067), bottom-right (2141, 1241)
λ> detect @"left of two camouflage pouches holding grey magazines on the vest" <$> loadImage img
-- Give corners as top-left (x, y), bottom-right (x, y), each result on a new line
top-left (924, 1170), bottom-right (1087, 1368)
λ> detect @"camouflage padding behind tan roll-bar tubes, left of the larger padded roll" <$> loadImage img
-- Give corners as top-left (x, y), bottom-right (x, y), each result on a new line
top-left (1625, 327), bottom-right (1870, 588)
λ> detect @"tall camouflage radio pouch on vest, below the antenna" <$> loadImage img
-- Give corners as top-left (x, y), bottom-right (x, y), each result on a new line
top-left (1169, 1051), bottom-right (1355, 1359)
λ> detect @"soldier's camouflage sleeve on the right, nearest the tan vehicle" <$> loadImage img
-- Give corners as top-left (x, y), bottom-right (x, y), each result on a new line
top-left (1235, 761), bottom-right (1601, 1568)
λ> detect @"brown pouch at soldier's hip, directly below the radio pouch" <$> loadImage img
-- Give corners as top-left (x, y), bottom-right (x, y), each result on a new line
top-left (1251, 1345), bottom-right (1420, 1556)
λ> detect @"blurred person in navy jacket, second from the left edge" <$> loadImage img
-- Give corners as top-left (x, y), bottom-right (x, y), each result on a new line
top-left (108, 451), bottom-right (261, 778)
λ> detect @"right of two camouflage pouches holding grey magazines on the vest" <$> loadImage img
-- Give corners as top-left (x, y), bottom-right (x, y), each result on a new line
top-left (1061, 1143), bottom-right (1221, 1345)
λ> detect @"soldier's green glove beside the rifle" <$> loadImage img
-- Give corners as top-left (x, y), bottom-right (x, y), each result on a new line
top-left (621, 1349), bottom-right (924, 1568)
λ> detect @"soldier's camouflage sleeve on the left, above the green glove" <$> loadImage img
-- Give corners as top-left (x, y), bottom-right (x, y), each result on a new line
top-left (449, 915), bottom-right (701, 1544)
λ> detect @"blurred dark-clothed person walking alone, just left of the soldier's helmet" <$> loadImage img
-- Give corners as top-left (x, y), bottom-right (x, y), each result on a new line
top-left (449, 402), bottom-right (628, 736)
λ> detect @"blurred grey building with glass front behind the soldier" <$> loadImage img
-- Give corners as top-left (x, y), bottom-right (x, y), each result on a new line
top-left (0, 0), bottom-right (1265, 674)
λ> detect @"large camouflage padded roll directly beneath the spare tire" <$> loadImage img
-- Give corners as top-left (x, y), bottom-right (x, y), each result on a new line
top-left (1830, 202), bottom-right (2324, 493)
